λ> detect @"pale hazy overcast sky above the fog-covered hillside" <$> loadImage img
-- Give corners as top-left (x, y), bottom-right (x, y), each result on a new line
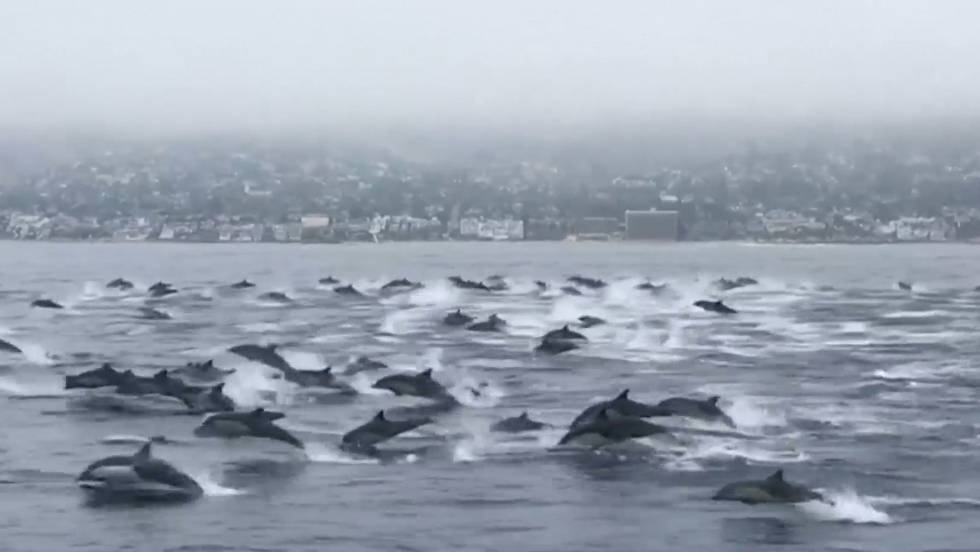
top-left (0, 0), bottom-right (980, 135)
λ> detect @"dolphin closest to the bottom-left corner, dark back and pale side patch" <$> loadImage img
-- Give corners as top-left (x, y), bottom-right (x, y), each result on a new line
top-left (76, 443), bottom-right (204, 502)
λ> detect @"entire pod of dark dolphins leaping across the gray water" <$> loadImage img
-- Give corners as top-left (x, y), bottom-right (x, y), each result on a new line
top-left (47, 275), bottom-right (856, 504)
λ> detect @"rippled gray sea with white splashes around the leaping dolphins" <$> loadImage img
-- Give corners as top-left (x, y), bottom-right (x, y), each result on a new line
top-left (0, 243), bottom-right (980, 552)
